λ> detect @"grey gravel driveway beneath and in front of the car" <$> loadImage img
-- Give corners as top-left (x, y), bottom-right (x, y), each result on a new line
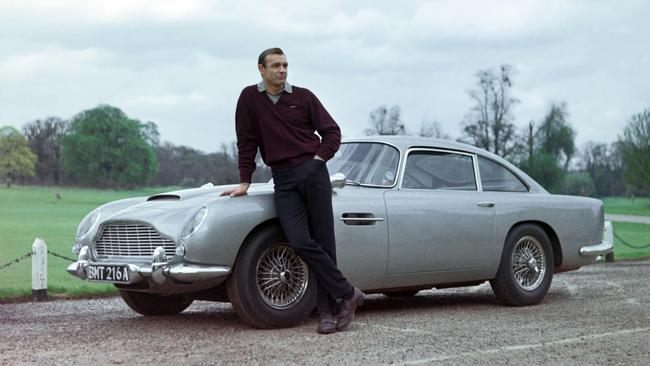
top-left (0, 261), bottom-right (650, 365)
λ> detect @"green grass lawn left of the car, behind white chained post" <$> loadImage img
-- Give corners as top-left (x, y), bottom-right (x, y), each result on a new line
top-left (0, 187), bottom-right (175, 299)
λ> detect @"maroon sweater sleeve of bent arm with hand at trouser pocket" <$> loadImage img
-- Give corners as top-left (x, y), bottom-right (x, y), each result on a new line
top-left (309, 92), bottom-right (341, 161)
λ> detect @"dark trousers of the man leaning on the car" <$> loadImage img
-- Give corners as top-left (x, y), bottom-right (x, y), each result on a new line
top-left (273, 159), bottom-right (352, 314)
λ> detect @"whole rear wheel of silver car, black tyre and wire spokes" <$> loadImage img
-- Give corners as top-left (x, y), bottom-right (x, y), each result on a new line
top-left (490, 224), bottom-right (555, 306)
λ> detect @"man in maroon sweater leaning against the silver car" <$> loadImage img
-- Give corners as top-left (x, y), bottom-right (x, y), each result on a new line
top-left (222, 48), bottom-right (364, 333)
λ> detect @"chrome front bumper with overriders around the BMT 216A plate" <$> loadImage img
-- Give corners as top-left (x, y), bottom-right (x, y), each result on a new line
top-left (67, 247), bottom-right (230, 284)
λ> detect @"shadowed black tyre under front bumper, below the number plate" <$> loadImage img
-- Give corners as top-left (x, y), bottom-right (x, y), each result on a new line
top-left (120, 290), bottom-right (193, 316)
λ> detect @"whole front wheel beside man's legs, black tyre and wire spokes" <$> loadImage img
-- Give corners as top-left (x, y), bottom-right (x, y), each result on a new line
top-left (226, 226), bottom-right (317, 328)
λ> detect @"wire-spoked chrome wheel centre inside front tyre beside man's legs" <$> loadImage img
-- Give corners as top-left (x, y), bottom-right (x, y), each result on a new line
top-left (256, 245), bottom-right (309, 310)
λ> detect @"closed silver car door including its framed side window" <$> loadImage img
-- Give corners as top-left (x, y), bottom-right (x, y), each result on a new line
top-left (384, 149), bottom-right (495, 286)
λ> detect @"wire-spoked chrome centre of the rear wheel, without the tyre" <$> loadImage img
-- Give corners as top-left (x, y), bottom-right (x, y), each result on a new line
top-left (512, 236), bottom-right (547, 291)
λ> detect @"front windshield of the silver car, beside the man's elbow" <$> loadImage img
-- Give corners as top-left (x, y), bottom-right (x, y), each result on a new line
top-left (327, 142), bottom-right (399, 187)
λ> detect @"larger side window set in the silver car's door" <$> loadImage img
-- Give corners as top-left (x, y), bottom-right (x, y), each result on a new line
top-left (402, 151), bottom-right (477, 191)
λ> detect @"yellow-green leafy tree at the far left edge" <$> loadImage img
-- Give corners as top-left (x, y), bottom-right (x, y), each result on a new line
top-left (0, 127), bottom-right (36, 188)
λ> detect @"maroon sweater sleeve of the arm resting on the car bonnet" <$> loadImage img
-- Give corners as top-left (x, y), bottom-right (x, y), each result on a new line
top-left (235, 89), bottom-right (258, 183)
